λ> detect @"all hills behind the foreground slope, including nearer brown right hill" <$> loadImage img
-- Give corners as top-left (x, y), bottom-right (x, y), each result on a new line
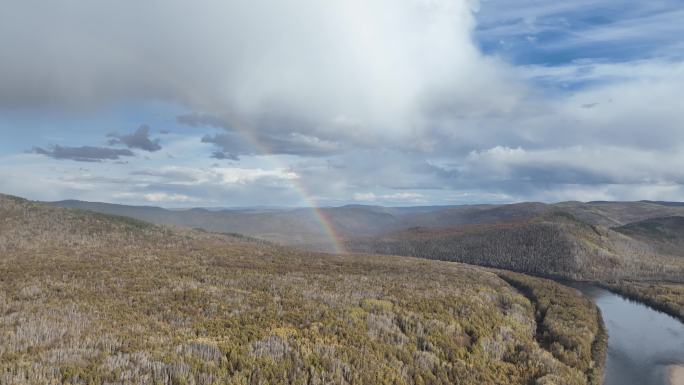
top-left (45, 195), bottom-right (684, 281)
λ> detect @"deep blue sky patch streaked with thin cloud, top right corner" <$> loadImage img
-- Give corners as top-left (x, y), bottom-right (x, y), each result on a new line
top-left (475, 0), bottom-right (684, 65)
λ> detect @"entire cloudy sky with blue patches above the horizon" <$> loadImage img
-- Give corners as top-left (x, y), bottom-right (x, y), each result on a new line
top-left (0, 0), bottom-right (684, 207)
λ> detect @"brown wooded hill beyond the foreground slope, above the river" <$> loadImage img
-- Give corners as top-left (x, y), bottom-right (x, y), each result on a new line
top-left (346, 212), bottom-right (684, 281)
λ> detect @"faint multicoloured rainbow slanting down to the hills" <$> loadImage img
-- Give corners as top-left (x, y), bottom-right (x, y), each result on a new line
top-left (216, 115), bottom-right (347, 254)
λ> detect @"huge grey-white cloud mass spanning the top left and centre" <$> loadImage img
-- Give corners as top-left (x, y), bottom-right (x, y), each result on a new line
top-left (0, 0), bottom-right (510, 139)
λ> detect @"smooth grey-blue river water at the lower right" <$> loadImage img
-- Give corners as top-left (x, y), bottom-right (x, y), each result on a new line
top-left (571, 283), bottom-right (684, 385)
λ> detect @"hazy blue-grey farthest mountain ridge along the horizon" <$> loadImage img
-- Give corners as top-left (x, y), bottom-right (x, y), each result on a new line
top-left (50, 196), bottom-right (684, 245)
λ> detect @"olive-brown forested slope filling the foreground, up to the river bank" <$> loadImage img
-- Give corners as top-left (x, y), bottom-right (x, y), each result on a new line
top-left (0, 196), bottom-right (602, 385)
